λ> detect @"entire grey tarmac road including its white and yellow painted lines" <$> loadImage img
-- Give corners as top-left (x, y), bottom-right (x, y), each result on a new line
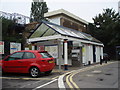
top-left (1, 62), bottom-right (120, 90)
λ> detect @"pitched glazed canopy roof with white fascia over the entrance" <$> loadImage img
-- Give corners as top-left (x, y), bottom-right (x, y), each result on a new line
top-left (28, 21), bottom-right (103, 46)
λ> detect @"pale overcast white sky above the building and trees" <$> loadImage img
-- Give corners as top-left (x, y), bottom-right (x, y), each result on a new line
top-left (0, 0), bottom-right (120, 22)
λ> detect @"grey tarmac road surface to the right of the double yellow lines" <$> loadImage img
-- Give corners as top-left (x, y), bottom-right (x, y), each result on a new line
top-left (73, 63), bottom-right (120, 89)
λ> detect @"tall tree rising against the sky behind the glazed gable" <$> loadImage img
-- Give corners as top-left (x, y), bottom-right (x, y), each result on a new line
top-left (30, 0), bottom-right (48, 22)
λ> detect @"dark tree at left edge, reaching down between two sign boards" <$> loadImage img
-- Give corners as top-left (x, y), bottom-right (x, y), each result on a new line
top-left (0, 17), bottom-right (24, 56)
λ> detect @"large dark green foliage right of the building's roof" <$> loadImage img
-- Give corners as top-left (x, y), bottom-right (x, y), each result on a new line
top-left (89, 8), bottom-right (120, 46)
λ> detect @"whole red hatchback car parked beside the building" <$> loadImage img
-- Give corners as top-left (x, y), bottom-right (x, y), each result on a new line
top-left (2, 50), bottom-right (55, 77)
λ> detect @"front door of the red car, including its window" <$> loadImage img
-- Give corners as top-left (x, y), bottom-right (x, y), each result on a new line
top-left (3, 52), bottom-right (24, 72)
